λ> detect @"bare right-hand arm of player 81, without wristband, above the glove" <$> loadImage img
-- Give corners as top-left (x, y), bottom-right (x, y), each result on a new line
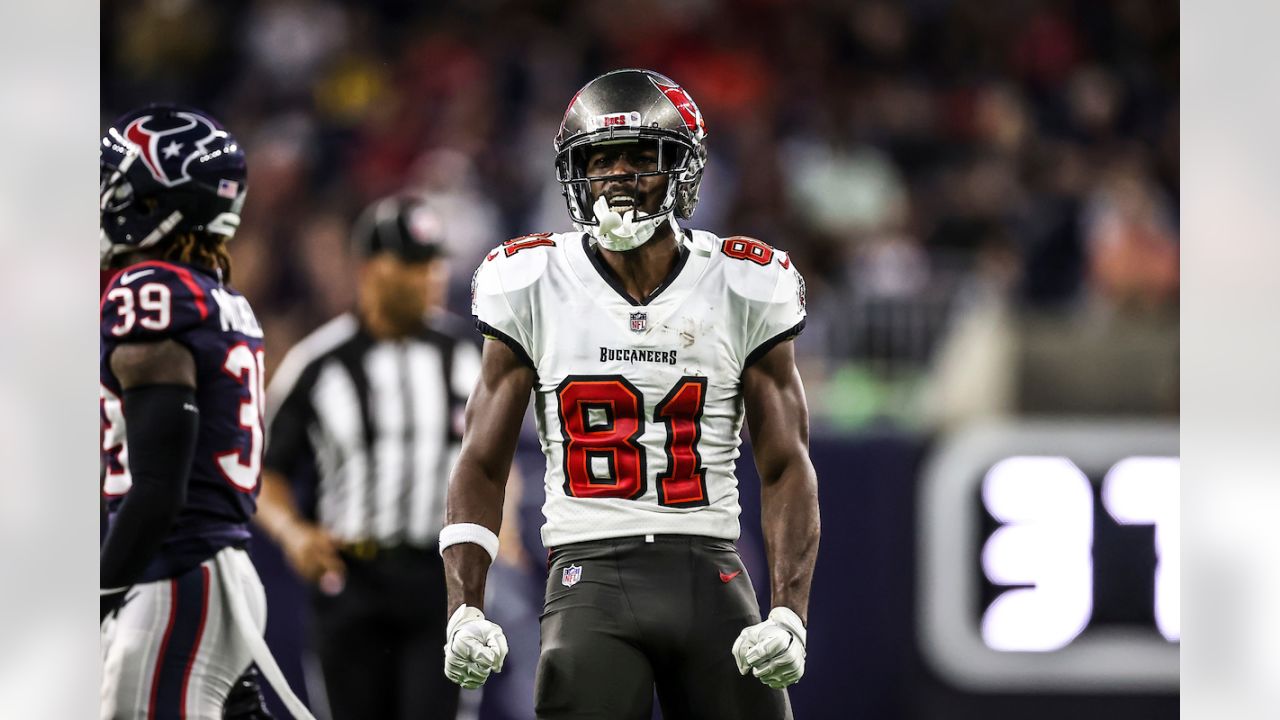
top-left (742, 342), bottom-right (820, 623)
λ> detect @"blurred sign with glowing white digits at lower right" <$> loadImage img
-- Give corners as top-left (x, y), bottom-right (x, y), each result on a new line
top-left (916, 421), bottom-right (1180, 694)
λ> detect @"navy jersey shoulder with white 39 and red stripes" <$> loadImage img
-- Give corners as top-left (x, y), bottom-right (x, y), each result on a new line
top-left (99, 260), bottom-right (214, 341)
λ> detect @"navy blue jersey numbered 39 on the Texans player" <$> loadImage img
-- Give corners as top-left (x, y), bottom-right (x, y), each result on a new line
top-left (99, 261), bottom-right (262, 582)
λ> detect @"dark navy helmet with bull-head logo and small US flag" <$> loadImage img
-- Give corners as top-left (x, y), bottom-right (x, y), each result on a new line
top-left (100, 105), bottom-right (248, 266)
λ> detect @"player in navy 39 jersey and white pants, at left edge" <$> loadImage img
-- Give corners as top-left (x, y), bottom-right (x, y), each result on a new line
top-left (100, 105), bottom-right (310, 719)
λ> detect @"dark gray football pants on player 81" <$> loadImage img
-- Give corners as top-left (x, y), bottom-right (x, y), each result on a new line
top-left (535, 536), bottom-right (791, 720)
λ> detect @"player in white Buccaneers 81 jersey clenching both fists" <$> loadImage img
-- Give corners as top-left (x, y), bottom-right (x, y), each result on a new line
top-left (440, 70), bottom-right (819, 720)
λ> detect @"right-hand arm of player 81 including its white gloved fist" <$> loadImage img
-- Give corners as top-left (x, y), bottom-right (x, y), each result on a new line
top-left (733, 342), bottom-right (820, 688)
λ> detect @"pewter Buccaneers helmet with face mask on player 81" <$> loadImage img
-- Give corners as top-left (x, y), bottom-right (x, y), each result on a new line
top-left (556, 69), bottom-right (707, 225)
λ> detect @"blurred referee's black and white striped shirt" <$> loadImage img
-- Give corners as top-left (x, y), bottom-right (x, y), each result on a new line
top-left (262, 313), bottom-right (480, 547)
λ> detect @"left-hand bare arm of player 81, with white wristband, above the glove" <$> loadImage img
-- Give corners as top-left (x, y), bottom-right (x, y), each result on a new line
top-left (443, 338), bottom-right (534, 614)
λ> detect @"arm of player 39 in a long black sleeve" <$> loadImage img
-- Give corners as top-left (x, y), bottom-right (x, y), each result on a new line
top-left (99, 340), bottom-right (200, 619)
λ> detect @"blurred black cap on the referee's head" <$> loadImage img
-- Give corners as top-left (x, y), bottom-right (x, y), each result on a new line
top-left (351, 195), bottom-right (444, 263)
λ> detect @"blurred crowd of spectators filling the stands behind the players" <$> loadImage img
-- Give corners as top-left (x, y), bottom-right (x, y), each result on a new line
top-left (101, 0), bottom-right (1179, 432)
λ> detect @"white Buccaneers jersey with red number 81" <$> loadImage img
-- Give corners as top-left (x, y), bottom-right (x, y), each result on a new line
top-left (471, 231), bottom-right (805, 547)
